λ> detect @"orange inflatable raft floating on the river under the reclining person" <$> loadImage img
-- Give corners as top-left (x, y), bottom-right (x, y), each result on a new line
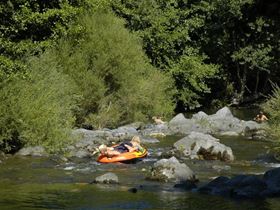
top-left (97, 148), bottom-right (148, 163)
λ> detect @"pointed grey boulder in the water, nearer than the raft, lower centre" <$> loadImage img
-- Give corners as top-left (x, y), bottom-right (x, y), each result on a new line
top-left (148, 157), bottom-right (196, 183)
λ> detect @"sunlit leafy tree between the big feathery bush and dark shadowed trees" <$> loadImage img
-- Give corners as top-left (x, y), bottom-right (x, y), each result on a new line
top-left (112, 0), bottom-right (218, 111)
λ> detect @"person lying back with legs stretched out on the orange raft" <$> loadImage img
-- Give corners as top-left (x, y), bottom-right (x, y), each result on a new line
top-left (98, 136), bottom-right (143, 157)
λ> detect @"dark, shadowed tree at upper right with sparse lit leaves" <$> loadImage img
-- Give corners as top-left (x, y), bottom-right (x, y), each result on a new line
top-left (199, 0), bottom-right (279, 103)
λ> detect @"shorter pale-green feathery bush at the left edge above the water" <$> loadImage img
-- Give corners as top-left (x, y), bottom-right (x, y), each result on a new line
top-left (0, 53), bottom-right (75, 152)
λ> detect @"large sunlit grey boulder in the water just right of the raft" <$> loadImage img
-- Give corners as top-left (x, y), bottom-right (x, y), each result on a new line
top-left (174, 132), bottom-right (234, 161)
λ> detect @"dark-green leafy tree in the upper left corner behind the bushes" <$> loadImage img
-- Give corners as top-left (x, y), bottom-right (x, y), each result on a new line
top-left (0, 0), bottom-right (96, 79)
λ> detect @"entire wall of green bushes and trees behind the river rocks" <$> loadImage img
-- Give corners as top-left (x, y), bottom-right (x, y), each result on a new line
top-left (0, 0), bottom-right (280, 151)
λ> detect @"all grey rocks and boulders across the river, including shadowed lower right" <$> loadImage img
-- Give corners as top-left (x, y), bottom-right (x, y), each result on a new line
top-left (10, 107), bottom-right (280, 198)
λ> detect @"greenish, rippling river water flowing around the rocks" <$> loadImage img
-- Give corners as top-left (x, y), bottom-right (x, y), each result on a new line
top-left (0, 107), bottom-right (280, 210)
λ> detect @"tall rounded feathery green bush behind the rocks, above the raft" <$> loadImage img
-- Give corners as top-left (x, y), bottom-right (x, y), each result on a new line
top-left (50, 10), bottom-right (174, 128)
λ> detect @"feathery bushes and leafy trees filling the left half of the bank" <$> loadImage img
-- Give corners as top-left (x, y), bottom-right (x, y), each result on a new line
top-left (0, 0), bottom-right (174, 152)
